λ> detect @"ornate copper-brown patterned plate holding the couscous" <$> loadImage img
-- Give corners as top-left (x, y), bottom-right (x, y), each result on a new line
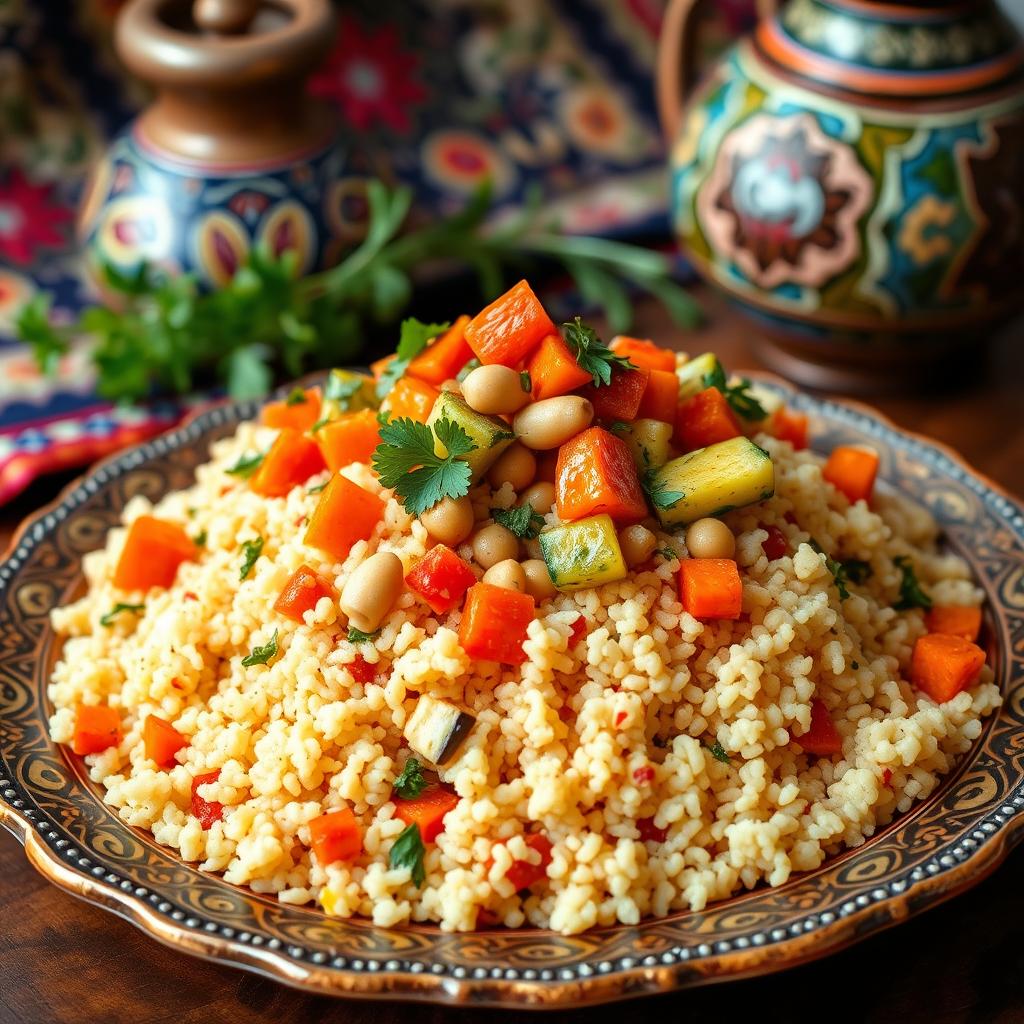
top-left (0, 381), bottom-right (1024, 1007)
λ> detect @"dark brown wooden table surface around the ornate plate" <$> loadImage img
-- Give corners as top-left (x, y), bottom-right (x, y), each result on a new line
top-left (0, 286), bottom-right (1024, 1024)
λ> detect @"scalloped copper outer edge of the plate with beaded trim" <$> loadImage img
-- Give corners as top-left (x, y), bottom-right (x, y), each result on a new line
top-left (0, 371), bottom-right (1024, 1009)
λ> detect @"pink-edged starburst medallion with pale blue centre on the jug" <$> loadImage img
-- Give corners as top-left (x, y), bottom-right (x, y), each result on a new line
top-left (697, 114), bottom-right (871, 288)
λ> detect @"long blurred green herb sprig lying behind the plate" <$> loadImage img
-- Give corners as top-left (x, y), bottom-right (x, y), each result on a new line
top-left (16, 181), bottom-right (699, 401)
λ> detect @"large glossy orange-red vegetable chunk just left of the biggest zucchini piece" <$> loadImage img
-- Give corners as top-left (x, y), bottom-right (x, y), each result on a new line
top-left (555, 427), bottom-right (647, 523)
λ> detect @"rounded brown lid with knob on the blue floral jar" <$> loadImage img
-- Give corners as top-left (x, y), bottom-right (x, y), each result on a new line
top-left (115, 0), bottom-right (334, 90)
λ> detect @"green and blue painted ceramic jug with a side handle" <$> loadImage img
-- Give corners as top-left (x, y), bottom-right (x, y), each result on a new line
top-left (658, 0), bottom-right (1024, 384)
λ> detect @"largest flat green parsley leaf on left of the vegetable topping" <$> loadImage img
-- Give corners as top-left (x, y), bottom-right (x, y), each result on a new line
top-left (373, 418), bottom-right (474, 516)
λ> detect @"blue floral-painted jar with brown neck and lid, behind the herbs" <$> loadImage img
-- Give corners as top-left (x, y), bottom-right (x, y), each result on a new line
top-left (80, 0), bottom-right (362, 286)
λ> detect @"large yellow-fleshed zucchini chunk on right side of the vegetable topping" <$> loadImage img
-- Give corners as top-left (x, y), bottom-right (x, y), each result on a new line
top-left (647, 437), bottom-right (775, 536)
